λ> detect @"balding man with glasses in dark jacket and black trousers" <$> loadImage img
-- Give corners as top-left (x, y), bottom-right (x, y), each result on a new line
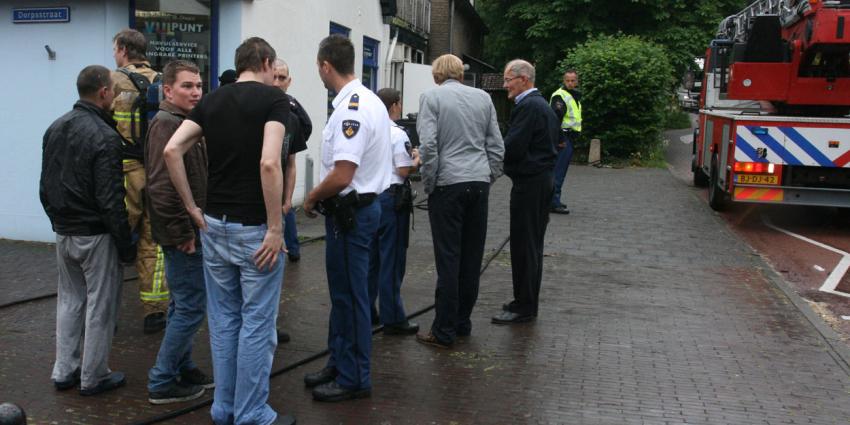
top-left (492, 59), bottom-right (558, 324)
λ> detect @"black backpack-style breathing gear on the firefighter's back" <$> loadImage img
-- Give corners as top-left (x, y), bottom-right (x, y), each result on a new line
top-left (118, 68), bottom-right (162, 161)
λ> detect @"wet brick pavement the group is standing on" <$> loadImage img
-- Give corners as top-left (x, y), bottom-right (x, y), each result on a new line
top-left (0, 161), bottom-right (850, 424)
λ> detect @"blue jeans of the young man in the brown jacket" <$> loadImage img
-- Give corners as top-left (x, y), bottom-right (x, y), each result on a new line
top-left (148, 246), bottom-right (207, 392)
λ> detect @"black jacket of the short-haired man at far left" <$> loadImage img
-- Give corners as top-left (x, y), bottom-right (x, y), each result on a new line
top-left (39, 100), bottom-right (136, 262)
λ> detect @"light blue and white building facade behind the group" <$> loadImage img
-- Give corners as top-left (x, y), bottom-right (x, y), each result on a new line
top-left (0, 0), bottom-right (390, 241)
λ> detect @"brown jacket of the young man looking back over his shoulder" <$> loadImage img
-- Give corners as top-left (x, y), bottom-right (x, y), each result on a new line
top-left (145, 100), bottom-right (207, 246)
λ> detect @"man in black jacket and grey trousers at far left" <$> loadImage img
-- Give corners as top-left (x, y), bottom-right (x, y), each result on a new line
top-left (39, 65), bottom-right (136, 395)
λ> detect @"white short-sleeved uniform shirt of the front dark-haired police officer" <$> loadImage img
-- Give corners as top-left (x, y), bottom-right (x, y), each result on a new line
top-left (319, 79), bottom-right (392, 195)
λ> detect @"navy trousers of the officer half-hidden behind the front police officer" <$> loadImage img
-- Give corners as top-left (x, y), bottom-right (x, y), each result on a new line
top-left (369, 190), bottom-right (410, 325)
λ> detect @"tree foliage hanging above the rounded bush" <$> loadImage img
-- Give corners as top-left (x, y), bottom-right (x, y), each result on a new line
top-left (476, 0), bottom-right (752, 90)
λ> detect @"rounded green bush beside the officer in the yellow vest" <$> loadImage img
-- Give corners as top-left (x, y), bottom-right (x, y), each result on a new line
top-left (561, 35), bottom-right (675, 159)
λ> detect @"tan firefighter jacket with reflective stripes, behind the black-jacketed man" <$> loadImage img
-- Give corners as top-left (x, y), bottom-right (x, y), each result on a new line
top-left (112, 61), bottom-right (157, 161)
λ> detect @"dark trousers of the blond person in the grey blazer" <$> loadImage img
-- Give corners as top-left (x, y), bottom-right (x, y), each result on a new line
top-left (428, 182), bottom-right (490, 344)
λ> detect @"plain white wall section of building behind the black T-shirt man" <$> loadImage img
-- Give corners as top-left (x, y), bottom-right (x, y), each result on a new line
top-left (237, 0), bottom-right (389, 204)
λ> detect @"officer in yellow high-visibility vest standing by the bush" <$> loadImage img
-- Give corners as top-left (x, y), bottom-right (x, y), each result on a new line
top-left (549, 69), bottom-right (581, 214)
